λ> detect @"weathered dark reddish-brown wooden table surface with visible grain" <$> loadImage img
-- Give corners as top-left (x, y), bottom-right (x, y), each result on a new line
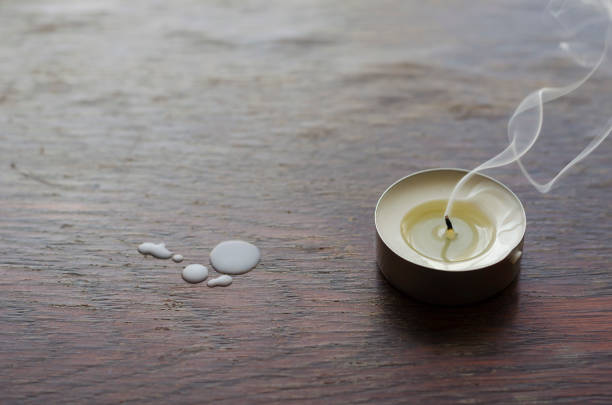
top-left (0, 0), bottom-right (612, 404)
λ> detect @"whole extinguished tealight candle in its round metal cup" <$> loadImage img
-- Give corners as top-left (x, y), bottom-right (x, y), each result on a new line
top-left (374, 169), bottom-right (526, 305)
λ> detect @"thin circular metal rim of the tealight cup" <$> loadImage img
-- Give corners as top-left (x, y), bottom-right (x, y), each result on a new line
top-left (374, 167), bottom-right (527, 273)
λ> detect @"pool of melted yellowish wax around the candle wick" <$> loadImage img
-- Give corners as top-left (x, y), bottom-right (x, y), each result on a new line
top-left (400, 200), bottom-right (496, 263)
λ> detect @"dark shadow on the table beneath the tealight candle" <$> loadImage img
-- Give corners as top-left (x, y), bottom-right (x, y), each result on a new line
top-left (377, 270), bottom-right (520, 345)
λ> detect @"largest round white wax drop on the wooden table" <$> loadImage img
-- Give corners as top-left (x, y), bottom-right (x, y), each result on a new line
top-left (210, 240), bottom-right (261, 275)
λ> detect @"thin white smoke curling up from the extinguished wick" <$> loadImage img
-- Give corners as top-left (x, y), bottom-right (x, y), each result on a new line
top-left (444, 0), bottom-right (612, 215)
